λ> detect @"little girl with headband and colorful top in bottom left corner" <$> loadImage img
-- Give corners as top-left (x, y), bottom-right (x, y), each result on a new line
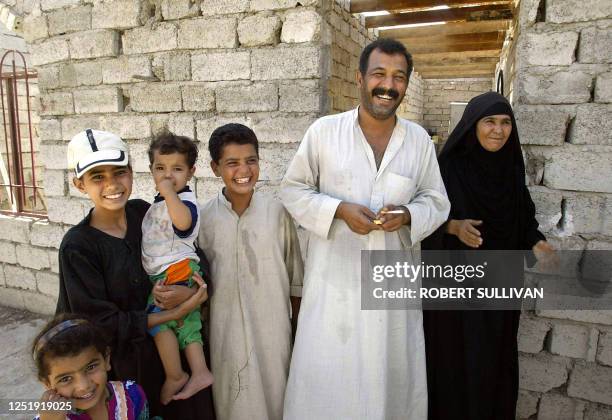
top-left (32, 314), bottom-right (157, 420)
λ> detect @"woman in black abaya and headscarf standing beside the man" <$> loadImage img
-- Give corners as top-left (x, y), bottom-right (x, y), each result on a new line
top-left (423, 92), bottom-right (553, 420)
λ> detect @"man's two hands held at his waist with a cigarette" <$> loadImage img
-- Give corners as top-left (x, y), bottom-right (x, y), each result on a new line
top-left (336, 202), bottom-right (411, 235)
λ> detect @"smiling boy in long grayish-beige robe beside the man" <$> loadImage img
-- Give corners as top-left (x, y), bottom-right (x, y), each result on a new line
top-left (198, 124), bottom-right (303, 420)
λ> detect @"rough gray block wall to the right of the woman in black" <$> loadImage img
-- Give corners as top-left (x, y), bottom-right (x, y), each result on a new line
top-left (513, 0), bottom-right (612, 420)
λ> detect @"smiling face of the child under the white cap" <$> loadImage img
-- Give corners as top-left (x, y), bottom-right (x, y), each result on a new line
top-left (73, 165), bottom-right (132, 212)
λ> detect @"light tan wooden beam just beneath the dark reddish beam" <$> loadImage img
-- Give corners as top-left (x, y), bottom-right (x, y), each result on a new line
top-left (378, 19), bottom-right (512, 39)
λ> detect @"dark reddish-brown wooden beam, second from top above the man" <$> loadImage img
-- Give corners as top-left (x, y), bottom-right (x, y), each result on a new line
top-left (366, 4), bottom-right (512, 28)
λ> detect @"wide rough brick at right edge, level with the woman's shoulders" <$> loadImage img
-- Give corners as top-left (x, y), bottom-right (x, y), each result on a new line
top-left (544, 147), bottom-right (612, 193)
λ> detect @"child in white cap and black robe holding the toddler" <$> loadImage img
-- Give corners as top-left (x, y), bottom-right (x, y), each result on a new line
top-left (56, 129), bottom-right (213, 420)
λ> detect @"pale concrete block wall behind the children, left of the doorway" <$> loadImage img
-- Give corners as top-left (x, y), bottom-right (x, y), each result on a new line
top-left (0, 0), bottom-right (332, 313)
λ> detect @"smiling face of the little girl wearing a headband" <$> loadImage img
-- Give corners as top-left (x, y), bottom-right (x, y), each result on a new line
top-left (45, 346), bottom-right (110, 410)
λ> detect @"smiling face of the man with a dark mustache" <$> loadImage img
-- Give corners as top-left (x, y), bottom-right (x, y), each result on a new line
top-left (357, 49), bottom-right (408, 120)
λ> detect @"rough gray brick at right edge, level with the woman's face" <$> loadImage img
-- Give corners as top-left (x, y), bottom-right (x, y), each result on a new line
top-left (570, 104), bottom-right (612, 146)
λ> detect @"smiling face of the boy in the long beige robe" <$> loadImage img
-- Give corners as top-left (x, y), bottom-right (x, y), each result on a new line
top-left (210, 143), bottom-right (259, 197)
